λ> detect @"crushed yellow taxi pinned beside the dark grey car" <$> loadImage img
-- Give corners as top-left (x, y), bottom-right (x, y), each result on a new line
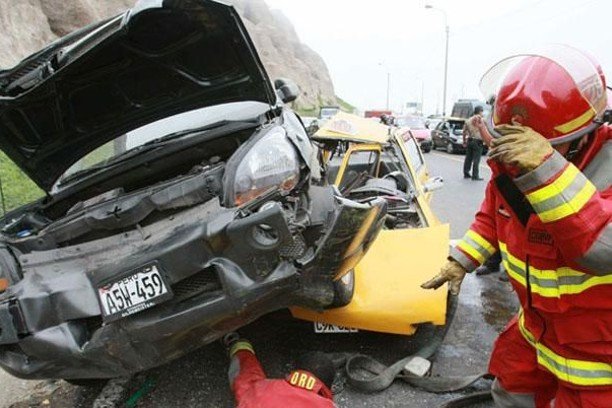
top-left (291, 112), bottom-right (449, 335)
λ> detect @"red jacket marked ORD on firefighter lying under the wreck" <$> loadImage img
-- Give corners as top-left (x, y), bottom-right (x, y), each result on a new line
top-left (229, 350), bottom-right (335, 408)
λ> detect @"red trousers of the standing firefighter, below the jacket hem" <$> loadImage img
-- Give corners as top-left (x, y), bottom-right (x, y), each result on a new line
top-left (489, 318), bottom-right (612, 408)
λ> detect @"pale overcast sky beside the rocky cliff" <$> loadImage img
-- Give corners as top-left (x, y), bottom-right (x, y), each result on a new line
top-left (266, 0), bottom-right (612, 113)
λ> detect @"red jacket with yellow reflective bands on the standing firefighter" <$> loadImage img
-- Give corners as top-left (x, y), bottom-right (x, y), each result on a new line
top-left (451, 127), bottom-right (612, 388)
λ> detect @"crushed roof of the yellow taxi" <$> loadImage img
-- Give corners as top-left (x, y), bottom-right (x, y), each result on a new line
top-left (312, 112), bottom-right (389, 144)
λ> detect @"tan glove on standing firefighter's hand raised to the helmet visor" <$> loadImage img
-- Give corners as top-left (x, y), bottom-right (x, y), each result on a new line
top-left (489, 125), bottom-right (553, 174)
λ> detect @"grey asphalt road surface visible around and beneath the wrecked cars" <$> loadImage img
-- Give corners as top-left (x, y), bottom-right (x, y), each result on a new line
top-left (0, 152), bottom-right (517, 408)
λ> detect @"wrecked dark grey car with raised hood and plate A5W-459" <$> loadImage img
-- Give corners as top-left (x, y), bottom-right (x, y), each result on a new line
top-left (0, 0), bottom-right (385, 379)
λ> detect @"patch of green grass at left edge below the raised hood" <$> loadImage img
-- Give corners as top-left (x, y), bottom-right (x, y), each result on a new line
top-left (0, 151), bottom-right (45, 215)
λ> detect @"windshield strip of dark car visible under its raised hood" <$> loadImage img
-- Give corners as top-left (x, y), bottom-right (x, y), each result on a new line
top-left (54, 102), bottom-right (270, 186)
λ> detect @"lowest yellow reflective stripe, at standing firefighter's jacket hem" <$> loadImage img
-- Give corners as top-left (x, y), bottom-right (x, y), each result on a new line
top-left (519, 309), bottom-right (612, 386)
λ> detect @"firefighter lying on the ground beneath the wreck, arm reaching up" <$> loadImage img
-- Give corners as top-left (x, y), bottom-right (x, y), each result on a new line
top-left (224, 333), bottom-right (336, 408)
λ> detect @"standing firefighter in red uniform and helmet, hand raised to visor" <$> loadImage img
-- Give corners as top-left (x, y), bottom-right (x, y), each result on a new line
top-left (422, 46), bottom-right (612, 408)
